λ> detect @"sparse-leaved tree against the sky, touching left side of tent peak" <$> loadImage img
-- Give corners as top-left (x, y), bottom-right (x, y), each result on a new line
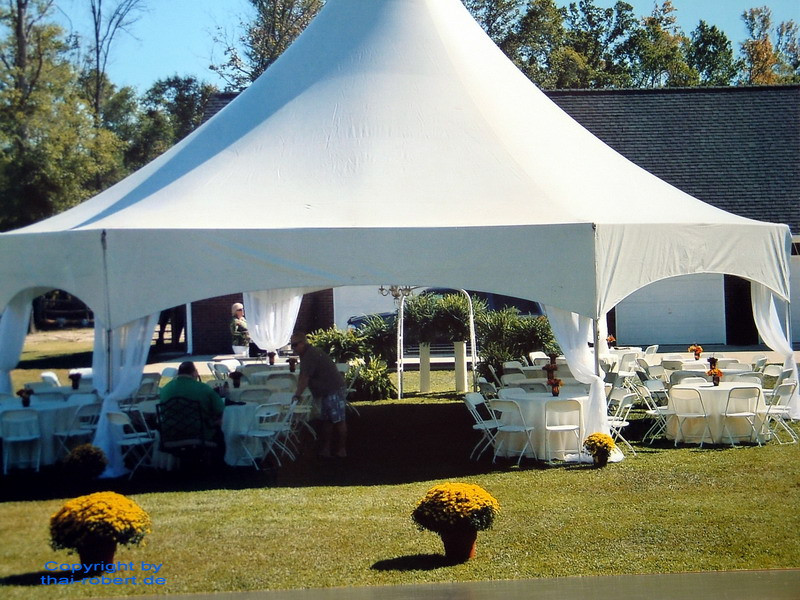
top-left (216, 0), bottom-right (324, 90)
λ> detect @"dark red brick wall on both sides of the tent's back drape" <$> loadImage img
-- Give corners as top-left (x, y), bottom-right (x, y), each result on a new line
top-left (192, 290), bottom-right (333, 354)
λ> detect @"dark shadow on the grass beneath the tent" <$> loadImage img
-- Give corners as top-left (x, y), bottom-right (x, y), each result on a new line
top-left (0, 400), bottom-right (548, 502)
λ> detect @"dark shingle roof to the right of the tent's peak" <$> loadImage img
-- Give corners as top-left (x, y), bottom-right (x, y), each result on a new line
top-left (546, 85), bottom-right (800, 235)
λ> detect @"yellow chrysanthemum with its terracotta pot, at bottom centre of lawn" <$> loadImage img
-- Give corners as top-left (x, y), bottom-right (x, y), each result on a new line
top-left (411, 483), bottom-right (500, 563)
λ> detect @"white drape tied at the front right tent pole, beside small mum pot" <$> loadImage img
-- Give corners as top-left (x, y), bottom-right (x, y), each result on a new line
top-left (544, 306), bottom-right (609, 442)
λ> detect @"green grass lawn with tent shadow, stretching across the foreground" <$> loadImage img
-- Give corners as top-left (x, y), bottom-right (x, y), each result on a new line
top-left (0, 350), bottom-right (800, 599)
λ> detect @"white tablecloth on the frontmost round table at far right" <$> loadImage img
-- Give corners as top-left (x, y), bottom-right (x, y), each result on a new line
top-left (666, 381), bottom-right (767, 444)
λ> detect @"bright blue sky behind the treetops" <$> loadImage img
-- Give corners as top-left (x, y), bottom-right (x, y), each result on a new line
top-left (59, 0), bottom-right (800, 92)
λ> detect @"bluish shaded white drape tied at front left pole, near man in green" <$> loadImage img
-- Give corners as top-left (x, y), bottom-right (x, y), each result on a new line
top-left (92, 313), bottom-right (159, 477)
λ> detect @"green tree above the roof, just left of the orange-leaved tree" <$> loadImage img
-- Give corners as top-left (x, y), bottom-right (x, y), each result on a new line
top-left (686, 20), bottom-right (739, 86)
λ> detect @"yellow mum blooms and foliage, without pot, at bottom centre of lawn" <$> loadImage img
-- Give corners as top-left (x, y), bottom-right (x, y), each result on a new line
top-left (411, 483), bottom-right (500, 533)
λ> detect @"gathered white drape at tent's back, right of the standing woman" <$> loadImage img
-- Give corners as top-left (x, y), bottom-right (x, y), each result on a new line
top-left (243, 288), bottom-right (304, 352)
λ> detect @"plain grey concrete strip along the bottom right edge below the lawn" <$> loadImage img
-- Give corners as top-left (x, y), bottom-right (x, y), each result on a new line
top-left (128, 569), bottom-right (800, 600)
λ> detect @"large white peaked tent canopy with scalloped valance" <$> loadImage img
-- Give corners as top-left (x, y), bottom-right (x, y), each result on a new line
top-left (0, 0), bottom-right (791, 466)
